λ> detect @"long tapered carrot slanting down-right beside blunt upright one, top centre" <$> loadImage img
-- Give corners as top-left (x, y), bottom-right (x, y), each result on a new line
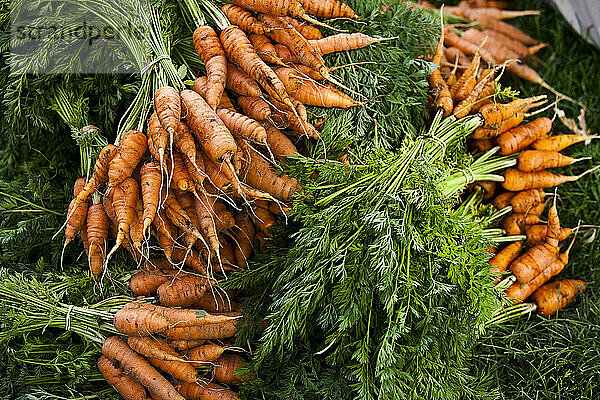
top-left (221, 26), bottom-right (293, 109)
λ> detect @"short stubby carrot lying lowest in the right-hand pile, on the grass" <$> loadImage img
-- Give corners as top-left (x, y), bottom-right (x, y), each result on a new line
top-left (531, 279), bottom-right (586, 316)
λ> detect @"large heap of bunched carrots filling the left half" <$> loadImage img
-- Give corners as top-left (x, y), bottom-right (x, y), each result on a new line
top-left (54, 0), bottom-right (398, 399)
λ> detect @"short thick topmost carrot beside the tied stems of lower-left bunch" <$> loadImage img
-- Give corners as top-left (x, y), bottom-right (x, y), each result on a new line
top-left (113, 303), bottom-right (169, 336)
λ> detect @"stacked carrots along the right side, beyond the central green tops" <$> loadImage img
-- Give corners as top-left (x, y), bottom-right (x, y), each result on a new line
top-left (430, 4), bottom-right (595, 315)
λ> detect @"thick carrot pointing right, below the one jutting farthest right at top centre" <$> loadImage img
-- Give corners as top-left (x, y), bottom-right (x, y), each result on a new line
top-left (275, 68), bottom-right (360, 108)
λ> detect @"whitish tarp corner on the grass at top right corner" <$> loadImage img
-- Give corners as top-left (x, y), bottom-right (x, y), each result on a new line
top-left (542, 0), bottom-right (600, 48)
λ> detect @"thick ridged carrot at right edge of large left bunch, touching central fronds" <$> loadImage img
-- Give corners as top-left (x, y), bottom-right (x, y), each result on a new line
top-left (241, 141), bottom-right (301, 201)
